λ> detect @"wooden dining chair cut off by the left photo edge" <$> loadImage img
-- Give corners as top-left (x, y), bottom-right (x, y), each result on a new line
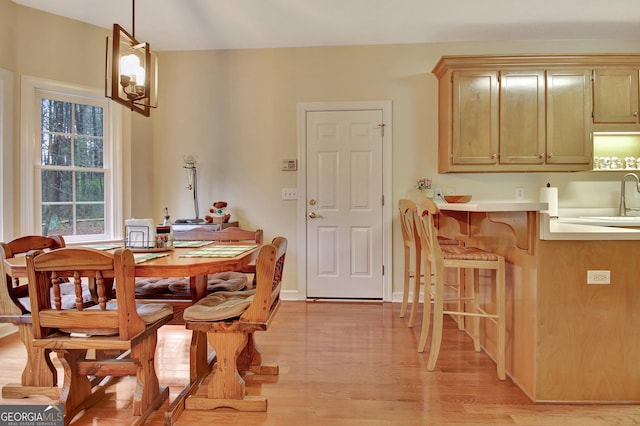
top-left (0, 235), bottom-right (65, 399)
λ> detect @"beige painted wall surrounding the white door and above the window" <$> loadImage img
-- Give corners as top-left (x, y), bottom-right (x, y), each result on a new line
top-left (0, 0), bottom-right (640, 300)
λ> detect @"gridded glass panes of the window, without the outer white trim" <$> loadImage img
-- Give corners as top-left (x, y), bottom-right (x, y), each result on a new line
top-left (39, 99), bottom-right (107, 236)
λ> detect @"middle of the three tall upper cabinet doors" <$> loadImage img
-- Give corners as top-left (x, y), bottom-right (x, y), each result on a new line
top-left (500, 71), bottom-right (545, 164)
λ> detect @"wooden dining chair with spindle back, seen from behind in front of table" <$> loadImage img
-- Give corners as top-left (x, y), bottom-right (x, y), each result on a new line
top-left (26, 247), bottom-right (173, 424)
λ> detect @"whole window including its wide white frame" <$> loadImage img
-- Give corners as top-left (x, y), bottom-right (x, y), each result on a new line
top-left (22, 78), bottom-right (122, 242)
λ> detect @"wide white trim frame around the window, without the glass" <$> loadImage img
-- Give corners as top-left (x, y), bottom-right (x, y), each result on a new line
top-left (20, 76), bottom-right (124, 244)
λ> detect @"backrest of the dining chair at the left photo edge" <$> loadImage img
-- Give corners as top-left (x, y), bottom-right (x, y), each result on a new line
top-left (0, 235), bottom-right (65, 315)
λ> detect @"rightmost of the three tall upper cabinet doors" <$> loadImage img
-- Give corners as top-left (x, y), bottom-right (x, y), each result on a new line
top-left (546, 69), bottom-right (592, 164)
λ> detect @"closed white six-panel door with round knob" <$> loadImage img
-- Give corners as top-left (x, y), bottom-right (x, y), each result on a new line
top-left (305, 110), bottom-right (384, 299)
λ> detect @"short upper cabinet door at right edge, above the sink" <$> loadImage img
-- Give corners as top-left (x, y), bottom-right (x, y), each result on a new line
top-left (593, 68), bottom-right (638, 123)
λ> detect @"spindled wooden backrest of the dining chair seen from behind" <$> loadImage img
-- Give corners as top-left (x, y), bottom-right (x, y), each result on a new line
top-left (26, 247), bottom-right (145, 340)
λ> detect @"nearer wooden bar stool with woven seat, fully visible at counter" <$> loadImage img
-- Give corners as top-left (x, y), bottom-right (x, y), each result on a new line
top-left (416, 199), bottom-right (506, 380)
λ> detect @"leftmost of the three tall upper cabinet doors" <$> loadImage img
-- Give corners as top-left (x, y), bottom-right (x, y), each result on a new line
top-left (451, 71), bottom-right (498, 164)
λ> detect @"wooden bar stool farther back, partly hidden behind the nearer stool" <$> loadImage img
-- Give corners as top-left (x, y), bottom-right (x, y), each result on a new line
top-left (398, 199), bottom-right (464, 329)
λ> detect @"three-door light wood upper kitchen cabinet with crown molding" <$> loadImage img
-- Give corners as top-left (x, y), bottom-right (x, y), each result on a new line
top-left (433, 55), bottom-right (640, 173)
